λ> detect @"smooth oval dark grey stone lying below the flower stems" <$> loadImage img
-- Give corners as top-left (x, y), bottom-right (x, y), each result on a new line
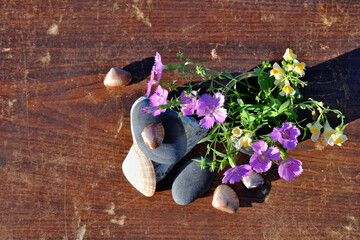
top-left (172, 158), bottom-right (214, 205)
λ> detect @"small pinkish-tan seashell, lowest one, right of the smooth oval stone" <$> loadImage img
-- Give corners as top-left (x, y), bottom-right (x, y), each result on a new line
top-left (212, 184), bottom-right (239, 213)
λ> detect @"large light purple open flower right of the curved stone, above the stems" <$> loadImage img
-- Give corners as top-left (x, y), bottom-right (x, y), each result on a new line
top-left (197, 92), bottom-right (227, 129)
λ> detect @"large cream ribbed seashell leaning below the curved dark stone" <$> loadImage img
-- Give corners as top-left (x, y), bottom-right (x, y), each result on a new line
top-left (122, 143), bottom-right (156, 197)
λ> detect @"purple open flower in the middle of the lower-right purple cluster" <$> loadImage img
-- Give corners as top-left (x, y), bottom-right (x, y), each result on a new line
top-left (250, 141), bottom-right (281, 173)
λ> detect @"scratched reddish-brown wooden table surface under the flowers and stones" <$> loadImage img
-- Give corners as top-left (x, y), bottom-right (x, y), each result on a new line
top-left (0, 0), bottom-right (360, 239)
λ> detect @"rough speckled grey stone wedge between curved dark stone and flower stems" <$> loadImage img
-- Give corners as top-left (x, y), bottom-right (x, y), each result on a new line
top-left (180, 116), bottom-right (208, 156)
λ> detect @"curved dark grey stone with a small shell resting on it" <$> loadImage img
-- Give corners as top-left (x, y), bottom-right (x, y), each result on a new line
top-left (130, 97), bottom-right (187, 164)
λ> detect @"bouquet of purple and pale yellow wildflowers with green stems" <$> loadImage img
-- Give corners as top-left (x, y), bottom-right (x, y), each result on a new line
top-left (142, 49), bottom-right (347, 184)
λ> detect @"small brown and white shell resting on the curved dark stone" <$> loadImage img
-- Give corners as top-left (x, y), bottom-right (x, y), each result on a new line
top-left (141, 122), bottom-right (165, 149)
